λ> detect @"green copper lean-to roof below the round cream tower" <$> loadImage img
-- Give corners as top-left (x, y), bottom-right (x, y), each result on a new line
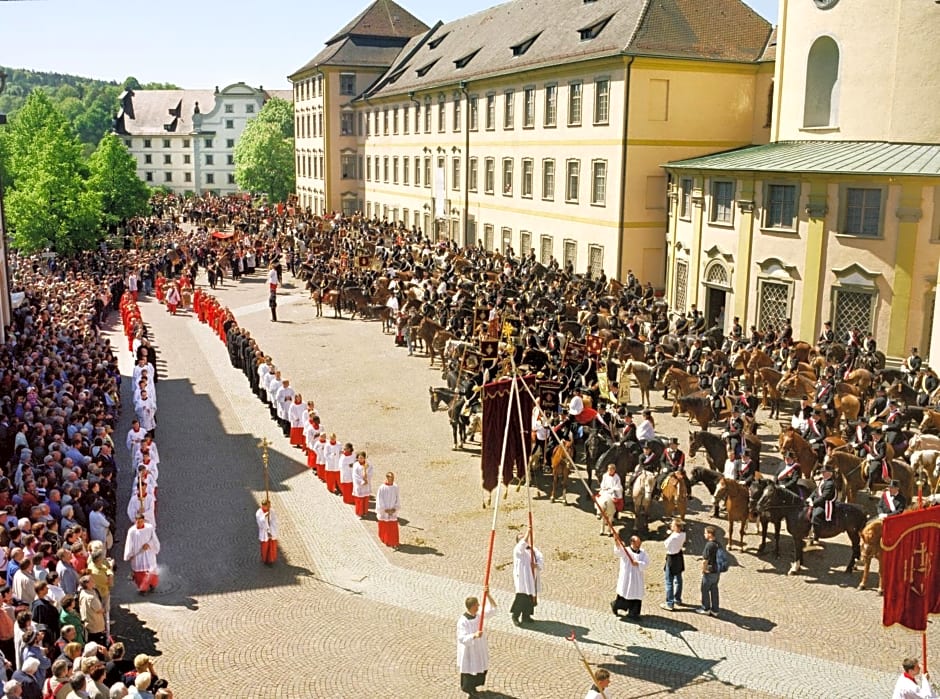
top-left (663, 141), bottom-right (940, 177)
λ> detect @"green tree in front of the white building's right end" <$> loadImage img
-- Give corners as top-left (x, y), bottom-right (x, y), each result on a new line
top-left (235, 98), bottom-right (295, 202)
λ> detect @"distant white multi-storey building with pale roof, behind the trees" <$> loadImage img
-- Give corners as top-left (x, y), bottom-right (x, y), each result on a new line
top-left (114, 83), bottom-right (292, 194)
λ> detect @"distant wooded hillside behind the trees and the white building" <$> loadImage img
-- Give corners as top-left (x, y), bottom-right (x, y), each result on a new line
top-left (0, 66), bottom-right (179, 150)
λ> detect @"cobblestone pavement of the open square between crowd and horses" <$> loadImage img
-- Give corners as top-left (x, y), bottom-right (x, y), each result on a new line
top-left (106, 266), bottom-right (940, 698)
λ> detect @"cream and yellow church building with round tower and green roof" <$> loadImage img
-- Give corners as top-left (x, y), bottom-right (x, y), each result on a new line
top-left (666, 0), bottom-right (940, 363)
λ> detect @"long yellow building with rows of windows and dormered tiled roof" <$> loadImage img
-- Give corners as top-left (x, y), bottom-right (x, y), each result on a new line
top-left (295, 0), bottom-right (773, 287)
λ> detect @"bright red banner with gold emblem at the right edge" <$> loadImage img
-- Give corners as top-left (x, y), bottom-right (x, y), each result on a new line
top-left (880, 507), bottom-right (940, 631)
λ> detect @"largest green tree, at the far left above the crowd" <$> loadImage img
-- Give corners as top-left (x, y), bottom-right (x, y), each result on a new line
top-left (4, 90), bottom-right (100, 253)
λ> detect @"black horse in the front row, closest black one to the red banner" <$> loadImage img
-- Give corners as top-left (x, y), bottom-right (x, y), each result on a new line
top-left (756, 481), bottom-right (867, 575)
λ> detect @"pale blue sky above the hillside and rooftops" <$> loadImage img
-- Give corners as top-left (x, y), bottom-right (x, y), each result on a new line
top-left (0, 0), bottom-right (777, 89)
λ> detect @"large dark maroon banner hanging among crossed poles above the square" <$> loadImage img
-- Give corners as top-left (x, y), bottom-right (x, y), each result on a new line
top-left (482, 376), bottom-right (535, 491)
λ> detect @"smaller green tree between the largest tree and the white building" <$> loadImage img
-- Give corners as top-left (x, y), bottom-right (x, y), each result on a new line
top-left (88, 134), bottom-right (150, 225)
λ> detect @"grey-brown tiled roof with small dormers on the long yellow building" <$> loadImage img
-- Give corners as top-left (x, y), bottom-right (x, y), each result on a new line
top-left (364, 0), bottom-right (771, 95)
